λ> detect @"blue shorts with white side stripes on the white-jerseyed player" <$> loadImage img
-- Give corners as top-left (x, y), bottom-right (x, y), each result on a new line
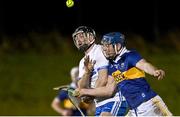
top-left (95, 101), bottom-right (128, 116)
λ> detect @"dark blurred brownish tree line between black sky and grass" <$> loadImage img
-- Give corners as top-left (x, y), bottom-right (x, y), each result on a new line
top-left (0, 29), bottom-right (180, 54)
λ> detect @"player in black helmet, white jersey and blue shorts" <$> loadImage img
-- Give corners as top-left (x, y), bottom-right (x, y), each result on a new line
top-left (72, 26), bottom-right (127, 116)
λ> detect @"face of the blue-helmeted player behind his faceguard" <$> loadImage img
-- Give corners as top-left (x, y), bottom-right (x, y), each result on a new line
top-left (102, 44), bottom-right (116, 59)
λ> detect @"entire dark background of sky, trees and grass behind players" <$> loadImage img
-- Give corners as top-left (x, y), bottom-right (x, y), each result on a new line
top-left (0, 0), bottom-right (180, 116)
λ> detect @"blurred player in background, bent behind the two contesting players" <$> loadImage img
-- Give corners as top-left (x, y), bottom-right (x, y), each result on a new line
top-left (51, 66), bottom-right (91, 116)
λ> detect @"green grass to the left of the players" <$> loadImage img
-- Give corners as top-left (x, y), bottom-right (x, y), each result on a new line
top-left (0, 51), bottom-right (80, 115)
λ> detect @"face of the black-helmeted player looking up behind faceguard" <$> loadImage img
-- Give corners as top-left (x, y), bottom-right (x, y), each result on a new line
top-left (74, 33), bottom-right (89, 51)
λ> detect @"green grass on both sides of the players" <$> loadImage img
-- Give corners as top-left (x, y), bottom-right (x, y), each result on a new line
top-left (0, 52), bottom-right (180, 115)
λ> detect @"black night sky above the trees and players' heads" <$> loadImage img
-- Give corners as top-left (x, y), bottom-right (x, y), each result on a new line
top-left (0, 0), bottom-right (180, 39)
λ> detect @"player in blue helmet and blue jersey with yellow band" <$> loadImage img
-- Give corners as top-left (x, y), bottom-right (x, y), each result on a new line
top-left (76, 32), bottom-right (172, 116)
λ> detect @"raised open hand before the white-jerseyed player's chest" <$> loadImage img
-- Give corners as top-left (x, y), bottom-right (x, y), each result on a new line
top-left (84, 56), bottom-right (96, 73)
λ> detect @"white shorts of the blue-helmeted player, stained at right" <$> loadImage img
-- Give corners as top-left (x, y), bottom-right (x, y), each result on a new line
top-left (127, 95), bottom-right (172, 116)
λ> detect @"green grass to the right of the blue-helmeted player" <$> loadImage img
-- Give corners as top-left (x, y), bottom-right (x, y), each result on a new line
top-left (148, 53), bottom-right (180, 116)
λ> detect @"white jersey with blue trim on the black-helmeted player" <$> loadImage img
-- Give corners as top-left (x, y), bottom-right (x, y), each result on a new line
top-left (79, 44), bottom-right (120, 107)
